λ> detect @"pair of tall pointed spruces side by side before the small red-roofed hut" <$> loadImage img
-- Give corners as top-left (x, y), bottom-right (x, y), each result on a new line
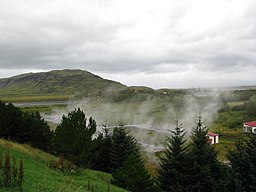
top-left (158, 117), bottom-right (230, 192)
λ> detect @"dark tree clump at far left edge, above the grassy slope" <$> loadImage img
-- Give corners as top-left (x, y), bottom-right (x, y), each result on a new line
top-left (0, 101), bottom-right (52, 151)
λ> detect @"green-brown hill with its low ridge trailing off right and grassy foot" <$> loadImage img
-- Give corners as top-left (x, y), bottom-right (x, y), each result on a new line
top-left (0, 69), bottom-right (188, 102)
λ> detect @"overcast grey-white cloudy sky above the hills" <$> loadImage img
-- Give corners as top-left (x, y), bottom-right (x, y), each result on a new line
top-left (0, 0), bottom-right (256, 89)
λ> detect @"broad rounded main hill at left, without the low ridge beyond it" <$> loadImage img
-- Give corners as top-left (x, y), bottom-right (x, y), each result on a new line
top-left (0, 70), bottom-right (126, 96)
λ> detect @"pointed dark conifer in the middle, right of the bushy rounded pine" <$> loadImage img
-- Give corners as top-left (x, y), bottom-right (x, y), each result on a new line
top-left (110, 123), bottom-right (138, 172)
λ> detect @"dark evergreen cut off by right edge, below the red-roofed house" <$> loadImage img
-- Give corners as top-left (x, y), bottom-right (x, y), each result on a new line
top-left (227, 135), bottom-right (256, 191)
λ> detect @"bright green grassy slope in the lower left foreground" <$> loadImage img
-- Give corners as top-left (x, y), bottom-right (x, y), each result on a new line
top-left (0, 139), bottom-right (125, 192)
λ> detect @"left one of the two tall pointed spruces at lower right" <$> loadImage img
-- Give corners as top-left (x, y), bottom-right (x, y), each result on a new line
top-left (158, 121), bottom-right (188, 191)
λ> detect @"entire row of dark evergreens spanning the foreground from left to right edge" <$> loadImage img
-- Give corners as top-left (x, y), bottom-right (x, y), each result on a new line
top-left (0, 102), bottom-right (256, 192)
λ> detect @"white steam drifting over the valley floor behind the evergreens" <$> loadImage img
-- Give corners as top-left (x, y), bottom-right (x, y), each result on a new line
top-left (43, 90), bottom-right (221, 152)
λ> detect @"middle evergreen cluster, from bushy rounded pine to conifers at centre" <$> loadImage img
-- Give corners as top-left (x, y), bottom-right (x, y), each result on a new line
top-left (54, 108), bottom-right (156, 192)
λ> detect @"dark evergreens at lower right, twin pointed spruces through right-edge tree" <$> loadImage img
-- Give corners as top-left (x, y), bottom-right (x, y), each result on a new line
top-left (157, 117), bottom-right (256, 192)
